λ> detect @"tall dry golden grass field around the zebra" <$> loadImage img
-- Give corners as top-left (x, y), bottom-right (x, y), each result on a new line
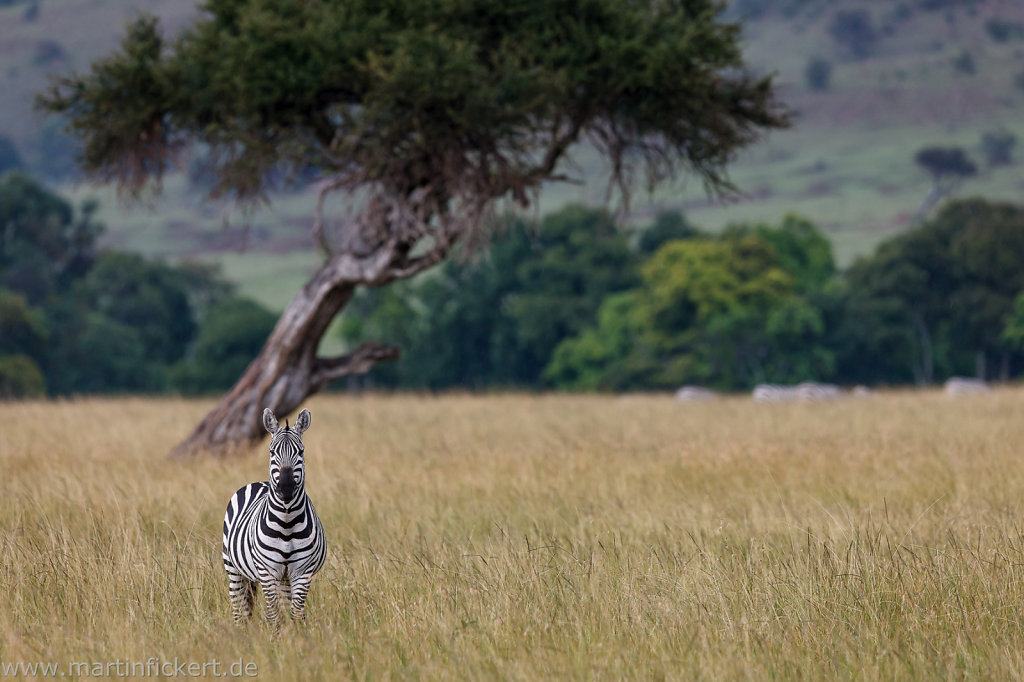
top-left (6, 389), bottom-right (1024, 680)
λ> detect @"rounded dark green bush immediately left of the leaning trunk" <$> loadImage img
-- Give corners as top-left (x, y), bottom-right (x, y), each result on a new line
top-left (170, 297), bottom-right (278, 394)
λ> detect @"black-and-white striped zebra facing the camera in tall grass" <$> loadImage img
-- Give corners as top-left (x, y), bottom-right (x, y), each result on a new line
top-left (223, 409), bottom-right (327, 630)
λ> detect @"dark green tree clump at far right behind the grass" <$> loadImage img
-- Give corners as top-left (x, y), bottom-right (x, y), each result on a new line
top-left (839, 200), bottom-right (1024, 383)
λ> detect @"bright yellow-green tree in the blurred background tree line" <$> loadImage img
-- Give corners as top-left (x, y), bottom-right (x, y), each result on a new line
top-left (545, 217), bottom-right (834, 390)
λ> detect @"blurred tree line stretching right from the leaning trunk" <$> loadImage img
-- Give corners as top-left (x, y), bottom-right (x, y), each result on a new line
top-left (342, 200), bottom-right (1024, 390)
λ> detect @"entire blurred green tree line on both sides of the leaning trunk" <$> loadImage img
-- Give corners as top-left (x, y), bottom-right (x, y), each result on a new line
top-left (6, 166), bottom-right (1024, 396)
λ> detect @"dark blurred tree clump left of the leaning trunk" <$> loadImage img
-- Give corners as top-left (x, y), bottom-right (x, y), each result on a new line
top-left (0, 173), bottom-right (276, 397)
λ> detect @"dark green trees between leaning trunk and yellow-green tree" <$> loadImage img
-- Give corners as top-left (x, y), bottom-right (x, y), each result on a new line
top-left (342, 207), bottom-right (638, 388)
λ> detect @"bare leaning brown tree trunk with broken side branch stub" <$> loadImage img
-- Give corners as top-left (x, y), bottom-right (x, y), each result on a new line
top-left (172, 238), bottom-right (444, 457)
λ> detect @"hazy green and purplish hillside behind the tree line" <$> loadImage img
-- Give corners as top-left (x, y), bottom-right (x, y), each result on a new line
top-left (0, 0), bottom-right (1024, 307)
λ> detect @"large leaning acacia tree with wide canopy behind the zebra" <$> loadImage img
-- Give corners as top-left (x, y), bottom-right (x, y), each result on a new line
top-left (39, 0), bottom-right (787, 454)
